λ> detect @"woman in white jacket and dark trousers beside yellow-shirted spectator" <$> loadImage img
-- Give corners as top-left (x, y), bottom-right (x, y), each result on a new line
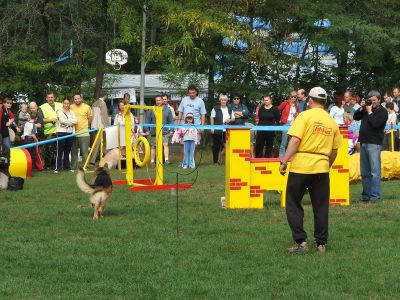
top-left (54, 98), bottom-right (76, 173)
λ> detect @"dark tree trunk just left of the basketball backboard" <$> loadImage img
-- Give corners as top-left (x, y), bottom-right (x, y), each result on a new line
top-left (94, 0), bottom-right (108, 98)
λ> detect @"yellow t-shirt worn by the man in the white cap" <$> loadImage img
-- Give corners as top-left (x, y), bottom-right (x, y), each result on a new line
top-left (288, 108), bottom-right (342, 174)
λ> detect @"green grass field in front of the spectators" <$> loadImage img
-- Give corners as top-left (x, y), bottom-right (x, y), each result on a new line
top-left (0, 165), bottom-right (400, 299)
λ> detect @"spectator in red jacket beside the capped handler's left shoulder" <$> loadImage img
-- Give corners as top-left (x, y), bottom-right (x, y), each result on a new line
top-left (278, 91), bottom-right (299, 157)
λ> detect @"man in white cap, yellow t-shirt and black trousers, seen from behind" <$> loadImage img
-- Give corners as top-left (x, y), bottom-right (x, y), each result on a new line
top-left (280, 87), bottom-right (342, 253)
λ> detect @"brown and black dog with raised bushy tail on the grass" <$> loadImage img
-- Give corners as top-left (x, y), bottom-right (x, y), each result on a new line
top-left (76, 164), bottom-right (112, 220)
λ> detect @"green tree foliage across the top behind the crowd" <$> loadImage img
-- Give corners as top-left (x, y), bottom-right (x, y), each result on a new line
top-left (0, 0), bottom-right (400, 99)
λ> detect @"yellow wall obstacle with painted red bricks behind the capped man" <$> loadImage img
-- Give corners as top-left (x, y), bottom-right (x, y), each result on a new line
top-left (225, 129), bottom-right (350, 208)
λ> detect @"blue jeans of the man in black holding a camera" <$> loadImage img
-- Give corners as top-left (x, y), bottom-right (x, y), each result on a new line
top-left (360, 144), bottom-right (382, 201)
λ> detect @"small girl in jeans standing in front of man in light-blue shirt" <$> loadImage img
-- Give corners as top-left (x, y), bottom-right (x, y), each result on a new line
top-left (182, 113), bottom-right (197, 169)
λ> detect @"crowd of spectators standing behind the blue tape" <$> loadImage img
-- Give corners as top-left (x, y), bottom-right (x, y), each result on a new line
top-left (0, 86), bottom-right (400, 173)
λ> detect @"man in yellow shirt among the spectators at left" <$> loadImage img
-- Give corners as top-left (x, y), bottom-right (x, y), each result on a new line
top-left (71, 93), bottom-right (92, 170)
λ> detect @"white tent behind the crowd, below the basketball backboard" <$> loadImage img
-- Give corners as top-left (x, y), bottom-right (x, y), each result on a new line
top-left (103, 74), bottom-right (208, 102)
